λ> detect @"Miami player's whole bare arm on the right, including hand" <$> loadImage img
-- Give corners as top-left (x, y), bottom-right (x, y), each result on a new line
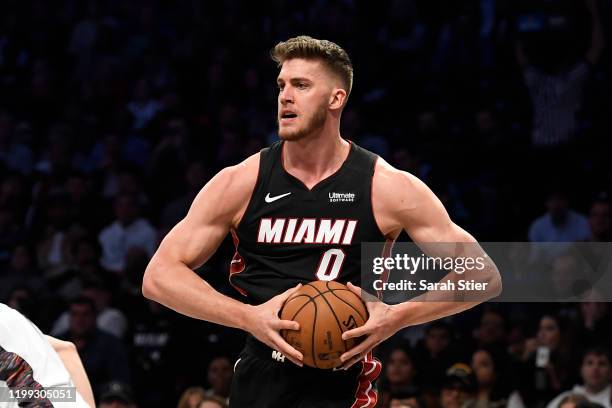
top-left (341, 159), bottom-right (501, 368)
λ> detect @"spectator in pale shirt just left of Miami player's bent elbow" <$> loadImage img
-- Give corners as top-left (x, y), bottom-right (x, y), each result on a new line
top-left (98, 195), bottom-right (157, 273)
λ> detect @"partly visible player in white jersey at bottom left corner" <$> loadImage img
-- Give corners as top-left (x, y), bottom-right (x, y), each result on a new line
top-left (0, 303), bottom-right (95, 408)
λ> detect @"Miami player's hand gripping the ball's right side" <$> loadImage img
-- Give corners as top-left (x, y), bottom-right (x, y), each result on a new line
top-left (340, 282), bottom-right (401, 370)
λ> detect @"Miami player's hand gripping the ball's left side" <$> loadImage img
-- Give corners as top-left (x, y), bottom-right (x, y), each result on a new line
top-left (247, 283), bottom-right (304, 367)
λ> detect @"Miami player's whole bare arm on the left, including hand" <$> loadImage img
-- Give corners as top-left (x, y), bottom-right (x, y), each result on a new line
top-left (142, 154), bottom-right (301, 363)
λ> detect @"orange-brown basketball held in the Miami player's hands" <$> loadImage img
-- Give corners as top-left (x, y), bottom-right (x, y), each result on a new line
top-left (280, 281), bottom-right (368, 369)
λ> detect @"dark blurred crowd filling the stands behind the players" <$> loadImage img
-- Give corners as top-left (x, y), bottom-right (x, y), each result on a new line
top-left (0, 0), bottom-right (612, 408)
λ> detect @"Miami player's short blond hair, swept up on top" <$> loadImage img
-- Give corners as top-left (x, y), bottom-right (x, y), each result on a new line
top-left (270, 35), bottom-right (353, 95)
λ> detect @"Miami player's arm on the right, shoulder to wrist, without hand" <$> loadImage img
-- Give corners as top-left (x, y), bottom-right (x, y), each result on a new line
top-left (375, 162), bottom-right (502, 328)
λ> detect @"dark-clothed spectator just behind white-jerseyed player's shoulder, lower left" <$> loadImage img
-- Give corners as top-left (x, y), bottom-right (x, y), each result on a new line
top-left (58, 297), bottom-right (130, 392)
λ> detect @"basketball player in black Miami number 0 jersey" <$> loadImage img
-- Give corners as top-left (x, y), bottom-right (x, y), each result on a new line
top-left (143, 36), bottom-right (501, 408)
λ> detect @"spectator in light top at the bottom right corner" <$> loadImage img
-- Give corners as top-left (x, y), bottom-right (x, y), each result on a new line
top-left (547, 347), bottom-right (612, 408)
